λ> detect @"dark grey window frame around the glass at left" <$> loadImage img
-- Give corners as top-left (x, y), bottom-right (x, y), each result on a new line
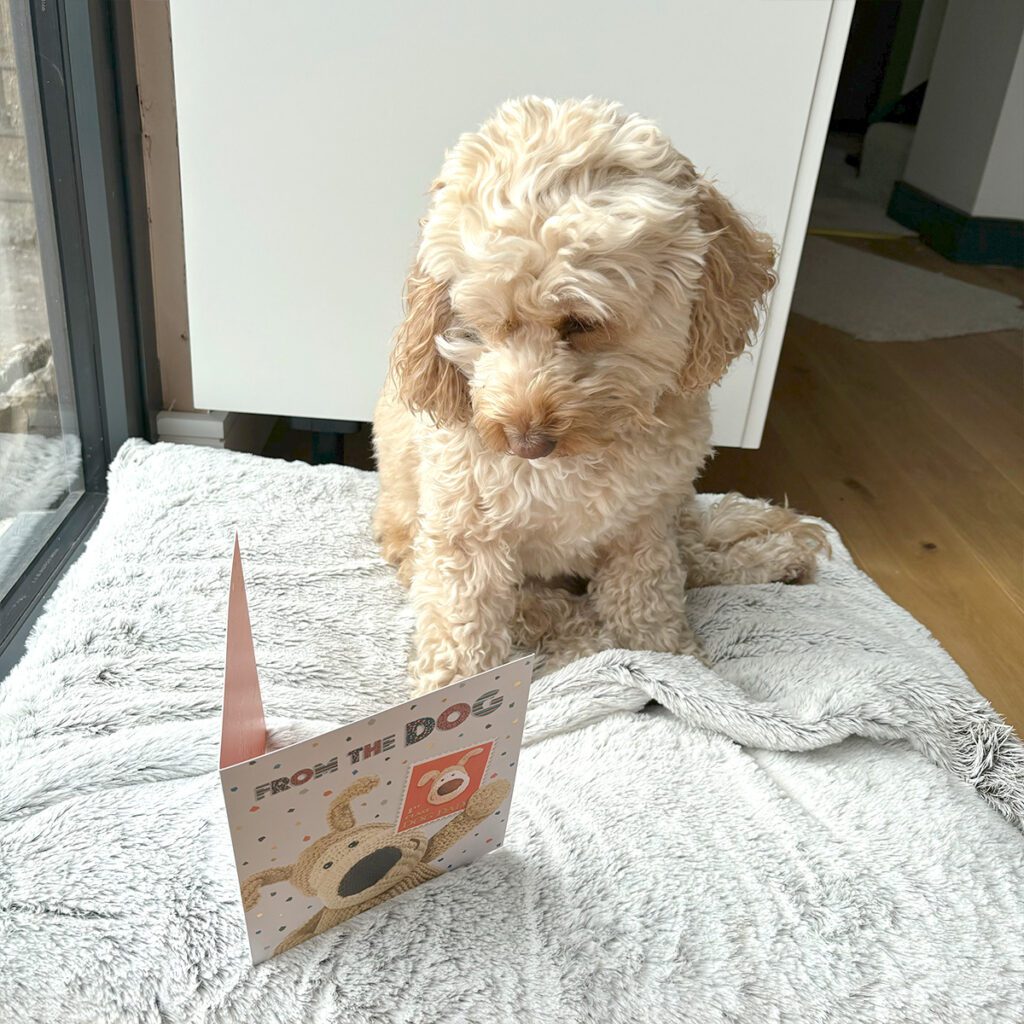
top-left (0, 0), bottom-right (161, 681)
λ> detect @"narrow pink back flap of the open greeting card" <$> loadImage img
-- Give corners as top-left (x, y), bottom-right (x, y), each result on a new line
top-left (220, 534), bottom-right (266, 768)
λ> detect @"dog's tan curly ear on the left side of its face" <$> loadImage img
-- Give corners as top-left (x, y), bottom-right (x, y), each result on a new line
top-left (391, 266), bottom-right (470, 426)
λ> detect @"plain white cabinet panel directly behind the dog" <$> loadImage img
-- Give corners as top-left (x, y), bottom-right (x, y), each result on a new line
top-left (171, 0), bottom-right (853, 446)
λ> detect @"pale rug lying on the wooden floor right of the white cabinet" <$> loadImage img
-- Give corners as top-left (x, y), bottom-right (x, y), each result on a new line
top-left (793, 238), bottom-right (1024, 341)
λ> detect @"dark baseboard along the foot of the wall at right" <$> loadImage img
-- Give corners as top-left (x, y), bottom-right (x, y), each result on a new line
top-left (887, 181), bottom-right (1024, 266)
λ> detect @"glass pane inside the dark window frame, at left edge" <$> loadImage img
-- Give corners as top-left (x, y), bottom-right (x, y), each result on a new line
top-left (0, 0), bottom-right (83, 594)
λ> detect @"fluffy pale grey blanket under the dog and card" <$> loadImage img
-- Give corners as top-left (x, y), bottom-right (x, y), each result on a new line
top-left (0, 442), bottom-right (1024, 1024)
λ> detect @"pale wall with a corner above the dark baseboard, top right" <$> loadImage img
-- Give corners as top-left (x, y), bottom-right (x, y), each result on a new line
top-left (904, 0), bottom-right (1024, 217)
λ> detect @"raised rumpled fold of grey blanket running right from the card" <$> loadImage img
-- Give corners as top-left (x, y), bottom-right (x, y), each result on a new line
top-left (526, 650), bottom-right (1024, 830)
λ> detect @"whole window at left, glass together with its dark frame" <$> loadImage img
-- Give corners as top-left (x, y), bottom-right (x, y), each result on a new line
top-left (0, 0), bottom-right (159, 671)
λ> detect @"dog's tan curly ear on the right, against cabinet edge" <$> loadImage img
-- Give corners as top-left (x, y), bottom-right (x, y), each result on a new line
top-left (680, 178), bottom-right (775, 391)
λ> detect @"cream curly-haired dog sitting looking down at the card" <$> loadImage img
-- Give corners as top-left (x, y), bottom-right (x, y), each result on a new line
top-left (375, 98), bottom-right (825, 691)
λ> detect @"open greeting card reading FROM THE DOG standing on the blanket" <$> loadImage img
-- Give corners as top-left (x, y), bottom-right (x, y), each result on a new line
top-left (220, 540), bottom-right (532, 964)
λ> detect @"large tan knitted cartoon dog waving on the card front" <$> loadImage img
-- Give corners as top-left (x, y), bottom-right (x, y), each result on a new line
top-left (242, 775), bottom-right (512, 955)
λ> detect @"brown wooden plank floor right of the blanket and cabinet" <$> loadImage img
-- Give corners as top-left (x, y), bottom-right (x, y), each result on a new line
top-left (700, 240), bottom-right (1024, 736)
